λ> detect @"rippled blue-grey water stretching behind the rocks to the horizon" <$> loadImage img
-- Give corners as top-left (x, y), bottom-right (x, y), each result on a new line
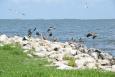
top-left (0, 19), bottom-right (115, 56)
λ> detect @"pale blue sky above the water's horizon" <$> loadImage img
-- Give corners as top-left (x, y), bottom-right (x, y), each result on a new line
top-left (0, 0), bottom-right (115, 19)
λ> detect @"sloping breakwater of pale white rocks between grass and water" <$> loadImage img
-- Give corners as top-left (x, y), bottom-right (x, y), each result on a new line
top-left (0, 35), bottom-right (115, 72)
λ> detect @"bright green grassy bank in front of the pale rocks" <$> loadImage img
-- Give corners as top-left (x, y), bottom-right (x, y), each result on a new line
top-left (0, 45), bottom-right (115, 77)
